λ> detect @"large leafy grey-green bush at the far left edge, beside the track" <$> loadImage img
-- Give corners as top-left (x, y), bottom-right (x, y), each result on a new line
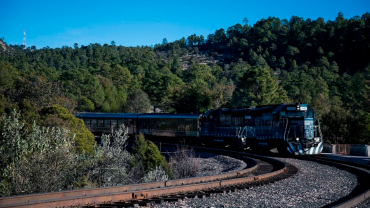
top-left (0, 111), bottom-right (78, 196)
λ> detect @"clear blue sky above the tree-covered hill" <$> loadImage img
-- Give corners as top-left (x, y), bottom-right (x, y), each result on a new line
top-left (0, 0), bottom-right (370, 48)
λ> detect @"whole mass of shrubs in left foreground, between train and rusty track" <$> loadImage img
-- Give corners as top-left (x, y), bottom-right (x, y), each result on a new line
top-left (0, 111), bottom-right (176, 196)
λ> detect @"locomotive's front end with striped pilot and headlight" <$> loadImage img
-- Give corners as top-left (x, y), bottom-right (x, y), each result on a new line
top-left (280, 104), bottom-right (323, 155)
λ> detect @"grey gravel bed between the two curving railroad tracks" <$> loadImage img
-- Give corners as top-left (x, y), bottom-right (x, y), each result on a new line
top-left (149, 158), bottom-right (357, 208)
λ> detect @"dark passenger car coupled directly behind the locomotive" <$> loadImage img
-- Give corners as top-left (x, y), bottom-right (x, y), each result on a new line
top-left (138, 113), bottom-right (201, 143)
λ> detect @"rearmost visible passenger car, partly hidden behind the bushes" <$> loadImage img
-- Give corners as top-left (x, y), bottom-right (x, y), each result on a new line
top-left (75, 112), bottom-right (139, 136)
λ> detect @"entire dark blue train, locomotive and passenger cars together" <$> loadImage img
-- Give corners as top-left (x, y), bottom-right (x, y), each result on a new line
top-left (75, 103), bottom-right (323, 155)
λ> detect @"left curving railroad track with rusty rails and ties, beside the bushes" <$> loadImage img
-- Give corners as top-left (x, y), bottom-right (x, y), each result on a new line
top-left (0, 147), bottom-right (290, 207)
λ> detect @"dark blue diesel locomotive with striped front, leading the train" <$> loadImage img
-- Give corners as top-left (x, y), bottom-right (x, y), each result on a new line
top-left (201, 104), bottom-right (323, 154)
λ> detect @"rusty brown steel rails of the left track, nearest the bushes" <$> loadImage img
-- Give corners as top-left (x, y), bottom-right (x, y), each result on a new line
top-left (0, 147), bottom-right (286, 207)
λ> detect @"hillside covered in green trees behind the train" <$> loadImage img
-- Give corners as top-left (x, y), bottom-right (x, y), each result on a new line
top-left (0, 13), bottom-right (370, 143)
